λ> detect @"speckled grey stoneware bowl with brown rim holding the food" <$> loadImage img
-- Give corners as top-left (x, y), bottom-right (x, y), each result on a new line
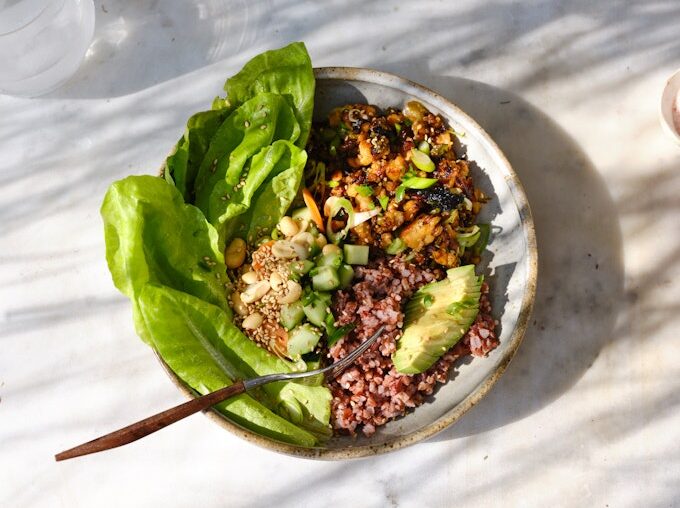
top-left (154, 67), bottom-right (537, 459)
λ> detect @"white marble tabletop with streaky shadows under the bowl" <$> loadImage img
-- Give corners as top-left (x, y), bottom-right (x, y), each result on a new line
top-left (0, 0), bottom-right (680, 507)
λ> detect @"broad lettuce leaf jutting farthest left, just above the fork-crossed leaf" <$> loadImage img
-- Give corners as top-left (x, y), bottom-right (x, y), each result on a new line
top-left (101, 176), bottom-right (229, 342)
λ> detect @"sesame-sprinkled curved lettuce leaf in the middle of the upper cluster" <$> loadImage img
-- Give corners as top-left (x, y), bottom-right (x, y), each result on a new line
top-left (195, 93), bottom-right (300, 225)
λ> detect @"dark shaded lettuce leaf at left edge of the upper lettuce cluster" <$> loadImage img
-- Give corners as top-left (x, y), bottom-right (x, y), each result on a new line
top-left (164, 101), bottom-right (233, 203)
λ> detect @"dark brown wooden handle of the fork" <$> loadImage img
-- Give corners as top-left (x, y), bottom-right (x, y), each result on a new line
top-left (54, 381), bottom-right (246, 461)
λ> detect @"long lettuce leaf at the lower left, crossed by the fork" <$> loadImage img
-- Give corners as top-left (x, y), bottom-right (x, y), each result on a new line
top-left (140, 285), bottom-right (331, 446)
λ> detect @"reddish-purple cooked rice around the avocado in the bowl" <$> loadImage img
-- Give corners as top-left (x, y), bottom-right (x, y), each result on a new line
top-left (328, 257), bottom-right (498, 436)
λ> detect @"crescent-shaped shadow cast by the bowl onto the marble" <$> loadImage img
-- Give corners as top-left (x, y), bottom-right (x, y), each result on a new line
top-left (390, 74), bottom-right (624, 440)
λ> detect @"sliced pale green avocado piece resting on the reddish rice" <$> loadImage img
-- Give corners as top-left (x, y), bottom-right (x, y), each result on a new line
top-left (392, 265), bottom-right (484, 374)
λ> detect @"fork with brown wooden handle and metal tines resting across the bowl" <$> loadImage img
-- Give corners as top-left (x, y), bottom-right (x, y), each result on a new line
top-left (54, 326), bottom-right (385, 461)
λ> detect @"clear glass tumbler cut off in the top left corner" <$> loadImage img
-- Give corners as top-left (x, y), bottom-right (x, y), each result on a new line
top-left (0, 0), bottom-right (94, 97)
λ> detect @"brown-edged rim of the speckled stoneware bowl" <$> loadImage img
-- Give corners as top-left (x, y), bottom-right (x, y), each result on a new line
top-left (154, 67), bottom-right (538, 460)
